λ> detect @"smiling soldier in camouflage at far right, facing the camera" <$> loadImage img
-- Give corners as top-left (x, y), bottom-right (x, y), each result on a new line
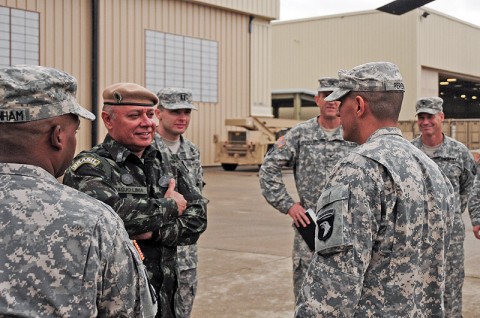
top-left (412, 97), bottom-right (476, 317)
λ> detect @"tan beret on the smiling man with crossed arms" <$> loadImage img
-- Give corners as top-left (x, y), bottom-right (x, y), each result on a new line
top-left (103, 83), bottom-right (158, 107)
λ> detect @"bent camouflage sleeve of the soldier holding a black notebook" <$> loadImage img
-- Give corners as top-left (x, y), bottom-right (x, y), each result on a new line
top-left (259, 130), bottom-right (297, 214)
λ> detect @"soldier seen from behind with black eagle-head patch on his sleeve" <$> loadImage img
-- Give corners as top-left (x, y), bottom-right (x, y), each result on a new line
top-left (295, 62), bottom-right (455, 318)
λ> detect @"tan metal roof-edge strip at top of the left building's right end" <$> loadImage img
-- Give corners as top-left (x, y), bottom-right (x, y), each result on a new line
top-left (190, 0), bottom-right (280, 20)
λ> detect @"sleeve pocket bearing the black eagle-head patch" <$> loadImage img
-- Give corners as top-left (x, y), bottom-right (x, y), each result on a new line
top-left (315, 185), bottom-right (352, 254)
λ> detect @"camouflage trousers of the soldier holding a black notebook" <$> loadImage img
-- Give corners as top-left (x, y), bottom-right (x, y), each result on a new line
top-left (292, 225), bottom-right (313, 302)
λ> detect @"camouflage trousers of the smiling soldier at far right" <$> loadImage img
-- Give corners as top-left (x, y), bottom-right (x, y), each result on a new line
top-left (445, 213), bottom-right (465, 318)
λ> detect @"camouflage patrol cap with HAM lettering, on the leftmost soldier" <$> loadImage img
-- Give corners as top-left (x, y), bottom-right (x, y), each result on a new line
top-left (0, 65), bottom-right (95, 123)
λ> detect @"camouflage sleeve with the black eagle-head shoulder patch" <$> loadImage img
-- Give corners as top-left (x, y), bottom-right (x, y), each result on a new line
top-left (295, 163), bottom-right (382, 317)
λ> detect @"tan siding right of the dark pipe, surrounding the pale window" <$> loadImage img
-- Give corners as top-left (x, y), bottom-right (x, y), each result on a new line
top-left (99, 0), bottom-right (251, 165)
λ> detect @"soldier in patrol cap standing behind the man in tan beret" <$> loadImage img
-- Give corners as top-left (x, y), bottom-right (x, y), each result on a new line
top-left (154, 88), bottom-right (203, 318)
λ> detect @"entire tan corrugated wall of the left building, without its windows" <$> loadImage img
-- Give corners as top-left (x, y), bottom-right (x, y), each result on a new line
top-left (0, 0), bottom-right (280, 165)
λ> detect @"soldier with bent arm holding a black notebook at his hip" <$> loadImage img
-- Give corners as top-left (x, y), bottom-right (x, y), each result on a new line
top-left (259, 77), bottom-right (356, 298)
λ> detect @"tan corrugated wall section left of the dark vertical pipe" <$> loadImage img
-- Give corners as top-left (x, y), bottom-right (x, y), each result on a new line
top-left (0, 0), bottom-right (91, 152)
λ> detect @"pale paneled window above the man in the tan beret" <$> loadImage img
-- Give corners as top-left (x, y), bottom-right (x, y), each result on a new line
top-left (145, 30), bottom-right (218, 103)
